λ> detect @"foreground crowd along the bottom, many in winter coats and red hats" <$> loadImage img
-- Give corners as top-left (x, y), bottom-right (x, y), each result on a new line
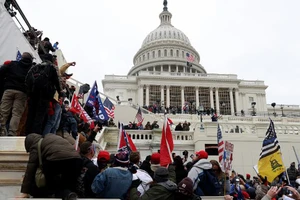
top-left (16, 139), bottom-right (300, 200)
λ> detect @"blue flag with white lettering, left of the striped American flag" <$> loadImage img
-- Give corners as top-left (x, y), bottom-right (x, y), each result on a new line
top-left (86, 81), bottom-right (109, 121)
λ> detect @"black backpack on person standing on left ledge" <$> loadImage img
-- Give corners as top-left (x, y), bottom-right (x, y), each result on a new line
top-left (26, 63), bottom-right (52, 92)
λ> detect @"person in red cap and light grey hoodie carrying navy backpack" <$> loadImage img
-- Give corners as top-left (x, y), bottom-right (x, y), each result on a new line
top-left (188, 150), bottom-right (212, 194)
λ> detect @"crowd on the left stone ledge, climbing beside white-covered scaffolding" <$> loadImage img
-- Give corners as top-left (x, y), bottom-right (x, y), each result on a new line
top-left (0, 37), bottom-right (115, 139)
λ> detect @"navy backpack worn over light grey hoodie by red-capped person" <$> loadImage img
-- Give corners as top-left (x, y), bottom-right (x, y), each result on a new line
top-left (195, 169), bottom-right (221, 196)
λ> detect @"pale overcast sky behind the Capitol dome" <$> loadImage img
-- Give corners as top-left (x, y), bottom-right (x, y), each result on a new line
top-left (18, 0), bottom-right (300, 104)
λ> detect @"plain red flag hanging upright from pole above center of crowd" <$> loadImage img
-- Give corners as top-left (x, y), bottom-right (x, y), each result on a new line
top-left (160, 116), bottom-right (174, 166)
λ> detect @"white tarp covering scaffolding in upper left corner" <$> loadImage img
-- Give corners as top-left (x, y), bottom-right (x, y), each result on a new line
top-left (0, 0), bottom-right (41, 65)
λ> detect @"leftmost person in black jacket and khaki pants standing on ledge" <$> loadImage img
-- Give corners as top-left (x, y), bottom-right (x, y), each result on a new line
top-left (0, 52), bottom-right (33, 136)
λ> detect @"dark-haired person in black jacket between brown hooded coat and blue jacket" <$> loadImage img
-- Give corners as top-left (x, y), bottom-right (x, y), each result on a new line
top-left (77, 141), bottom-right (100, 198)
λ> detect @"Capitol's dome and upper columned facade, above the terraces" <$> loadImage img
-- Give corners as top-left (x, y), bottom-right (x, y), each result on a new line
top-left (102, 1), bottom-right (268, 115)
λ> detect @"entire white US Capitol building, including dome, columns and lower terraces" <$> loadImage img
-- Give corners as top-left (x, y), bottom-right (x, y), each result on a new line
top-left (100, 1), bottom-right (300, 175)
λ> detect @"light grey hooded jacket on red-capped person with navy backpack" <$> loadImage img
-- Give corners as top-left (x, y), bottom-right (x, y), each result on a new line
top-left (187, 159), bottom-right (212, 190)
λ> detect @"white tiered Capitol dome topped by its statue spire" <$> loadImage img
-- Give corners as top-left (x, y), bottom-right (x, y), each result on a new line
top-left (128, 0), bottom-right (206, 76)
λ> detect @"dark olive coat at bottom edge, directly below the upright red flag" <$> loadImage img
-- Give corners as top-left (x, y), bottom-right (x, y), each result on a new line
top-left (130, 180), bottom-right (177, 200)
